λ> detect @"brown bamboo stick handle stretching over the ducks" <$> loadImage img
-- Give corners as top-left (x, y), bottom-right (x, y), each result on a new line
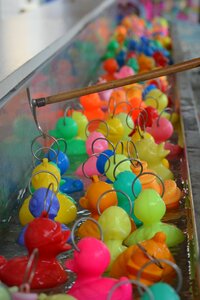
top-left (32, 57), bottom-right (200, 107)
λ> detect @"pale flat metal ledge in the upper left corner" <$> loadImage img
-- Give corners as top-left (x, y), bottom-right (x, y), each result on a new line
top-left (0, 0), bottom-right (114, 99)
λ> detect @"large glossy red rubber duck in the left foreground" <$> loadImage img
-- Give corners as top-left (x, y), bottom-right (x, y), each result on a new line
top-left (0, 216), bottom-right (71, 290)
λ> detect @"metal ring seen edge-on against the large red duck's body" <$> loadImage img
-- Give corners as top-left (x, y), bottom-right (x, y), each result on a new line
top-left (20, 248), bottom-right (39, 292)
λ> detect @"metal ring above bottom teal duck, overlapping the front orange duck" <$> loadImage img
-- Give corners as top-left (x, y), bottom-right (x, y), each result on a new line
top-left (137, 257), bottom-right (183, 294)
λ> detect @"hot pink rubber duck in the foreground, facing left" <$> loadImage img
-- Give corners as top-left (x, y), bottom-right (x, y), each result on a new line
top-left (66, 237), bottom-right (132, 300)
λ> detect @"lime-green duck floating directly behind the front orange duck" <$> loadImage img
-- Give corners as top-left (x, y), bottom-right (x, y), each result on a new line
top-left (125, 189), bottom-right (184, 247)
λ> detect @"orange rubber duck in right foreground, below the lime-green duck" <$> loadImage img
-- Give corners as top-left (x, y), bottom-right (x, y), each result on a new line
top-left (109, 232), bottom-right (174, 285)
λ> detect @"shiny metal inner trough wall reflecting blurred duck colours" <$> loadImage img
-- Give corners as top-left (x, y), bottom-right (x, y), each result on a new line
top-left (0, 1), bottom-right (115, 225)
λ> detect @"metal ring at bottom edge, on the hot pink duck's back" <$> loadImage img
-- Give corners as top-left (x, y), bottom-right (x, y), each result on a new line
top-left (107, 279), bottom-right (155, 300)
